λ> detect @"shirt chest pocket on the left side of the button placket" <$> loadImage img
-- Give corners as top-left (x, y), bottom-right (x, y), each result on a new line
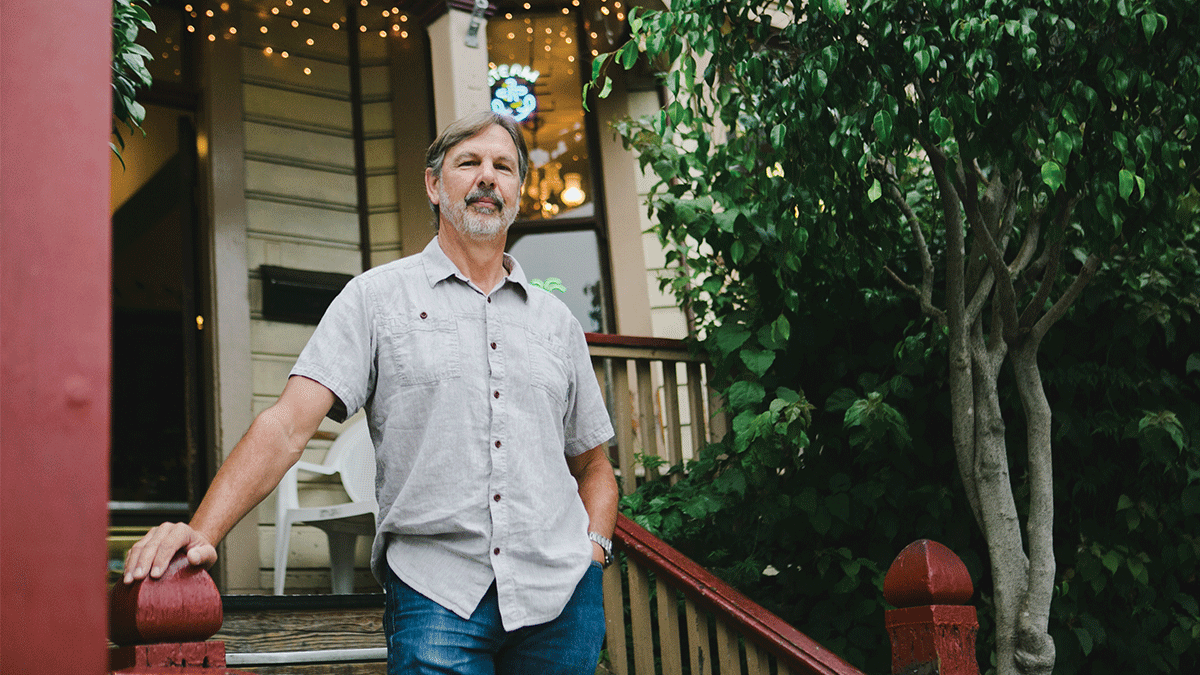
top-left (386, 312), bottom-right (462, 386)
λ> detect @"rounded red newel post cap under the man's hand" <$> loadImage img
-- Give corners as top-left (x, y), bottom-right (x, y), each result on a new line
top-left (108, 554), bottom-right (223, 646)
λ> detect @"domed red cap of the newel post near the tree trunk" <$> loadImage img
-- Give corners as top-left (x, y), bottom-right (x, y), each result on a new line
top-left (883, 539), bottom-right (974, 608)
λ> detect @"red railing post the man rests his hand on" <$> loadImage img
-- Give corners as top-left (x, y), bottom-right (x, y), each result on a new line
top-left (108, 555), bottom-right (253, 675)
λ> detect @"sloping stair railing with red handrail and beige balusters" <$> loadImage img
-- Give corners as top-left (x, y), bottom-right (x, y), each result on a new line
top-left (605, 515), bottom-right (862, 675)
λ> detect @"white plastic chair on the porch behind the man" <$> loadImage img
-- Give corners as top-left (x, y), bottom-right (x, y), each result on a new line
top-left (275, 418), bottom-right (379, 596)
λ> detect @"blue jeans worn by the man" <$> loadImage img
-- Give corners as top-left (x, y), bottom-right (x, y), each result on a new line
top-left (383, 562), bottom-right (605, 675)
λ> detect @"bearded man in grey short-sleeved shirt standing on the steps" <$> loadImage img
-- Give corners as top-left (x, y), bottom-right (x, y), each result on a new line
top-left (125, 113), bottom-right (617, 675)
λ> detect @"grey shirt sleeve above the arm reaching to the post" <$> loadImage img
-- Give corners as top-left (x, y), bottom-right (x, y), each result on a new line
top-left (290, 277), bottom-right (376, 423)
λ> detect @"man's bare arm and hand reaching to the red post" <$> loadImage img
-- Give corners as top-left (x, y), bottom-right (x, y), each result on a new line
top-left (125, 376), bottom-right (336, 584)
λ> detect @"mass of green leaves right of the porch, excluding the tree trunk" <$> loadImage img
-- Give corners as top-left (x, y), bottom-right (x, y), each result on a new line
top-left (593, 0), bottom-right (1200, 673)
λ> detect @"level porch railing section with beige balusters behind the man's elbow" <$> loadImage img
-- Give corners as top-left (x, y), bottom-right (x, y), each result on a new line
top-left (587, 333), bottom-right (728, 495)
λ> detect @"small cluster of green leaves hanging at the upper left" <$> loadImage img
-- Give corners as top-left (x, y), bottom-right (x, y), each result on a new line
top-left (109, 0), bottom-right (156, 167)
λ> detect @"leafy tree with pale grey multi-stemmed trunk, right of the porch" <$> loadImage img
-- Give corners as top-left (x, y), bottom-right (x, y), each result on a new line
top-left (594, 0), bottom-right (1200, 675)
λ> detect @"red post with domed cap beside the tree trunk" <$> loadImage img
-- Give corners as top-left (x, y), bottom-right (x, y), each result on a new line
top-left (883, 539), bottom-right (979, 675)
